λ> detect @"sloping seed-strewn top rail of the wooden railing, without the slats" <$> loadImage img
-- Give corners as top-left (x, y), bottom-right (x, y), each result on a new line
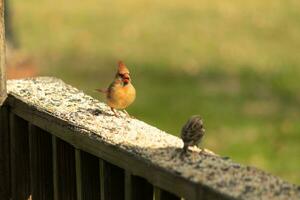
top-left (4, 77), bottom-right (300, 200)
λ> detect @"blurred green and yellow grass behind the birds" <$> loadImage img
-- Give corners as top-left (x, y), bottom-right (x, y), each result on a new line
top-left (11, 0), bottom-right (300, 184)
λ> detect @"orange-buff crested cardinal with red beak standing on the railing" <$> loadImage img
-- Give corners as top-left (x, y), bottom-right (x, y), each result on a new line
top-left (96, 61), bottom-right (136, 116)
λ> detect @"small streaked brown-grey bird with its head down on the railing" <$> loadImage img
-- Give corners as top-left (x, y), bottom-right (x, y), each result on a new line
top-left (181, 115), bottom-right (205, 153)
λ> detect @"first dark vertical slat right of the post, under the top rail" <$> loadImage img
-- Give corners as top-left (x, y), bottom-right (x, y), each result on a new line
top-left (9, 113), bottom-right (31, 200)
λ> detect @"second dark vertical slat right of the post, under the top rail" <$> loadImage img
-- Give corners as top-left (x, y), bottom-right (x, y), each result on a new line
top-left (29, 124), bottom-right (53, 200)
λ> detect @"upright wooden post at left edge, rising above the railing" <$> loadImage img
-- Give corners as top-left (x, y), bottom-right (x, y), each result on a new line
top-left (0, 0), bottom-right (6, 106)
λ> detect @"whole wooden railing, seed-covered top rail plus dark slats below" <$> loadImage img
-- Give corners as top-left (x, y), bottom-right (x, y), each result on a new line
top-left (0, 77), bottom-right (300, 200)
